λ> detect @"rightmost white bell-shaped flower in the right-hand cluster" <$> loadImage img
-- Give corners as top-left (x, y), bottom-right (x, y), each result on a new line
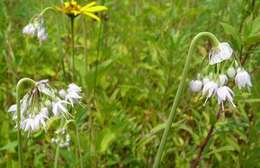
top-left (235, 68), bottom-right (252, 89)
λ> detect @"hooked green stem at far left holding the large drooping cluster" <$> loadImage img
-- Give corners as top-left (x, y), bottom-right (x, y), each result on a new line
top-left (16, 78), bottom-right (36, 168)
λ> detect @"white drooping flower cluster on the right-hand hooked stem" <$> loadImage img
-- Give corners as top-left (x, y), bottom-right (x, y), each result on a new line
top-left (190, 43), bottom-right (252, 109)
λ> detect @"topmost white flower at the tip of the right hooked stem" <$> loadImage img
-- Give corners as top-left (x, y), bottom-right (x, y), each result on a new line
top-left (209, 42), bottom-right (233, 65)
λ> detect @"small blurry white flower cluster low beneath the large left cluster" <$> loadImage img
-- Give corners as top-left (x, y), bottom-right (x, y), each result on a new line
top-left (51, 128), bottom-right (71, 148)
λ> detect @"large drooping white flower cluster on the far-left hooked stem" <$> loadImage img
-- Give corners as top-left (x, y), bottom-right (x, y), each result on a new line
top-left (8, 80), bottom-right (81, 132)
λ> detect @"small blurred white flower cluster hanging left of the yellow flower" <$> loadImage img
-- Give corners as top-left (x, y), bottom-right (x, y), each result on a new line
top-left (23, 18), bottom-right (48, 43)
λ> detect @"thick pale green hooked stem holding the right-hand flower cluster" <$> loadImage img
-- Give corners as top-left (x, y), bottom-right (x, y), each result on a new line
top-left (153, 32), bottom-right (219, 168)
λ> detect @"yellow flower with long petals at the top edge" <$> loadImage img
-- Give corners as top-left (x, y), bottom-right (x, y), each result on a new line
top-left (58, 0), bottom-right (107, 21)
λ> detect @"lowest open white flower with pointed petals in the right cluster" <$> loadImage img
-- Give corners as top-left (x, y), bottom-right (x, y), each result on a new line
top-left (217, 86), bottom-right (236, 110)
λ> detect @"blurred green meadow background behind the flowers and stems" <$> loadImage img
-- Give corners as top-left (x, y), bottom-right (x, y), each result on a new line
top-left (0, 0), bottom-right (260, 168)
